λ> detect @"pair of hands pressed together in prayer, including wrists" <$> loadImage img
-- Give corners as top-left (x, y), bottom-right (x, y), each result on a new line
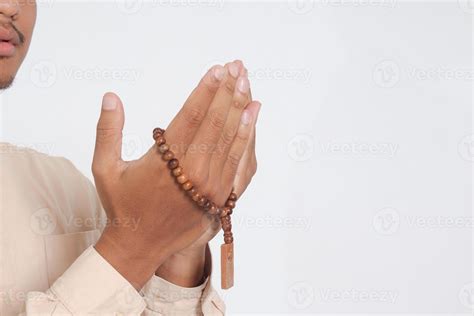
top-left (92, 61), bottom-right (261, 289)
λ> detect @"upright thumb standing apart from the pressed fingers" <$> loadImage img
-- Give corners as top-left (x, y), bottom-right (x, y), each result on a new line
top-left (92, 92), bottom-right (125, 174)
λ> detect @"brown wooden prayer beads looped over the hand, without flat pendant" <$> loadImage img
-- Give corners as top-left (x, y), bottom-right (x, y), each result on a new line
top-left (153, 128), bottom-right (237, 249)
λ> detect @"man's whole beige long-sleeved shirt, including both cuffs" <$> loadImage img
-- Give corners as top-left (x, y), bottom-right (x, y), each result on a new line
top-left (0, 143), bottom-right (225, 316)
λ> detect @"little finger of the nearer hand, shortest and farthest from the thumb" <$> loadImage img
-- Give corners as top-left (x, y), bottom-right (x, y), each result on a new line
top-left (222, 101), bottom-right (261, 187)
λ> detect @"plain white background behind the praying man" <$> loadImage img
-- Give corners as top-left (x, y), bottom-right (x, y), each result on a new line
top-left (0, 0), bottom-right (474, 314)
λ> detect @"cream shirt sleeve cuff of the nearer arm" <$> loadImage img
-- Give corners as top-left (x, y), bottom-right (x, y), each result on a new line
top-left (25, 246), bottom-right (146, 315)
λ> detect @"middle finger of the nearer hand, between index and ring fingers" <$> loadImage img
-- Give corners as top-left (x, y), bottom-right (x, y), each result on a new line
top-left (185, 63), bottom-right (240, 178)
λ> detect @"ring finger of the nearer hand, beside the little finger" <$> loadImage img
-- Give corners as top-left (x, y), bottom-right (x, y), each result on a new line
top-left (210, 72), bottom-right (250, 173)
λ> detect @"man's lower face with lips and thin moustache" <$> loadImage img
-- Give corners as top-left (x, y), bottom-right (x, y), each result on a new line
top-left (0, 0), bottom-right (36, 89)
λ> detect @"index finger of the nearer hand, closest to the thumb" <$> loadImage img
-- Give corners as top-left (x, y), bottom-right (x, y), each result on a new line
top-left (166, 65), bottom-right (226, 154)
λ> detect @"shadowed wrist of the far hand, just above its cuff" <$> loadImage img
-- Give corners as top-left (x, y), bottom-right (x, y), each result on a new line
top-left (155, 245), bottom-right (208, 287)
